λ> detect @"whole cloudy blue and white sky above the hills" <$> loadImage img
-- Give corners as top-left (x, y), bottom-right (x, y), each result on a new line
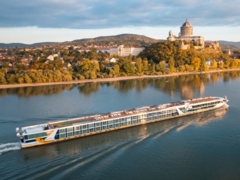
top-left (0, 0), bottom-right (240, 44)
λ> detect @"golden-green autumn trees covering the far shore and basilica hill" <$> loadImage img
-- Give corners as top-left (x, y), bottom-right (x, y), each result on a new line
top-left (0, 41), bottom-right (240, 88)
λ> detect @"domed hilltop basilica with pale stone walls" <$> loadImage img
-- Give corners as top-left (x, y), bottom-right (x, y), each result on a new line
top-left (167, 20), bottom-right (204, 48)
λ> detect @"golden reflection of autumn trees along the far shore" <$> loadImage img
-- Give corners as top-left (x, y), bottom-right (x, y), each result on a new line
top-left (0, 71), bottom-right (240, 99)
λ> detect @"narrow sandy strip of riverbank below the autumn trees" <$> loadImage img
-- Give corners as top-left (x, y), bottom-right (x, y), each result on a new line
top-left (0, 69), bottom-right (240, 89)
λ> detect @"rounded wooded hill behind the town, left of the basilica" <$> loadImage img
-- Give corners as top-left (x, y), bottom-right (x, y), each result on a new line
top-left (72, 34), bottom-right (164, 46)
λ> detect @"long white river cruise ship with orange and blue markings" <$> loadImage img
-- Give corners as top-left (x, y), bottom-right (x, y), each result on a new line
top-left (16, 97), bottom-right (228, 148)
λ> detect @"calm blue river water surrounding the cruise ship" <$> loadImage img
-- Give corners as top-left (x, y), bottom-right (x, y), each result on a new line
top-left (0, 72), bottom-right (240, 180)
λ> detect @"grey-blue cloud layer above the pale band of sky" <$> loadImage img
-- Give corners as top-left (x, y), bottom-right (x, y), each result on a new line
top-left (0, 0), bottom-right (240, 29)
